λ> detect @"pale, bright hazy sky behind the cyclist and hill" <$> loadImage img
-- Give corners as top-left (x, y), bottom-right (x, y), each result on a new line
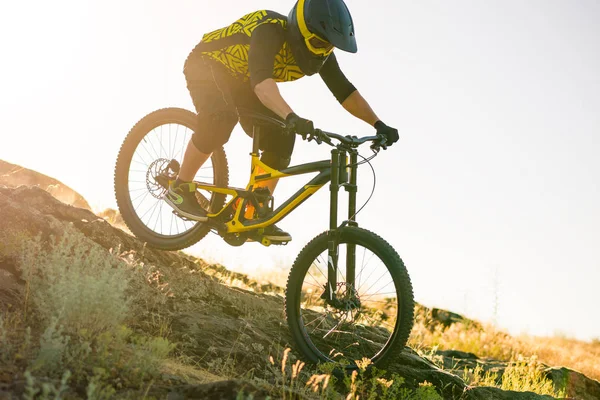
top-left (0, 0), bottom-right (600, 340)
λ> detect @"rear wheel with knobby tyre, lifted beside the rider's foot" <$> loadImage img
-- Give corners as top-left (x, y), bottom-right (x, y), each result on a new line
top-left (115, 108), bottom-right (229, 250)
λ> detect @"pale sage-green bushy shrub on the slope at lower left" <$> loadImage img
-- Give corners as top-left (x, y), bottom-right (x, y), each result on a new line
top-left (21, 229), bottom-right (132, 335)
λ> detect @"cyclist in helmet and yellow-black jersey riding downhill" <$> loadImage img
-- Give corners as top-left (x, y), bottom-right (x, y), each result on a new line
top-left (165, 0), bottom-right (398, 242)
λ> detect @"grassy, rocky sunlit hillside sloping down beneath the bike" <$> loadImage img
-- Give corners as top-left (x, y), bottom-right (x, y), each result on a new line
top-left (0, 161), bottom-right (600, 400)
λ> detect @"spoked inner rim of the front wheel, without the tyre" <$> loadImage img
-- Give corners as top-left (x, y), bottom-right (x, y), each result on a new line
top-left (297, 243), bottom-right (401, 365)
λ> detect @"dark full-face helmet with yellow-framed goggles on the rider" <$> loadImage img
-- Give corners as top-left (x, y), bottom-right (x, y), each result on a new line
top-left (287, 0), bottom-right (357, 75)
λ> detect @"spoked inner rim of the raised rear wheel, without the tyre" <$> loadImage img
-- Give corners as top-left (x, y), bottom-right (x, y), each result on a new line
top-left (127, 123), bottom-right (215, 238)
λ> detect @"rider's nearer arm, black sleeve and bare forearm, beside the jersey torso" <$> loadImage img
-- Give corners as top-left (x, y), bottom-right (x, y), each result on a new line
top-left (248, 23), bottom-right (293, 119)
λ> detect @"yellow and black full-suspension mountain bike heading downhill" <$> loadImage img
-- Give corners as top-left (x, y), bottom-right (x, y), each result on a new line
top-left (115, 108), bottom-right (414, 368)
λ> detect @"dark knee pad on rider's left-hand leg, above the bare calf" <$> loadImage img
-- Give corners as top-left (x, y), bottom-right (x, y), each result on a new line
top-left (192, 110), bottom-right (238, 154)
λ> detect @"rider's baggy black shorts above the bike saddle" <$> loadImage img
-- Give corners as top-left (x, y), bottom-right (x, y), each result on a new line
top-left (184, 57), bottom-right (295, 168)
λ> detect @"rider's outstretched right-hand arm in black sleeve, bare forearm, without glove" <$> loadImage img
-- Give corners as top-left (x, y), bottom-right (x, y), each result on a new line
top-left (319, 53), bottom-right (379, 126)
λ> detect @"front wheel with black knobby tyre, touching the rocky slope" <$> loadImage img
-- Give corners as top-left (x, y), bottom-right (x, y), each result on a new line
top-left (285, 227), bottom-right (414, 368)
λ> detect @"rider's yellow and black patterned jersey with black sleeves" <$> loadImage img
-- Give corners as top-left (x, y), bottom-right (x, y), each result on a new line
top-left (192, 10), bottom-right (356, 102)
